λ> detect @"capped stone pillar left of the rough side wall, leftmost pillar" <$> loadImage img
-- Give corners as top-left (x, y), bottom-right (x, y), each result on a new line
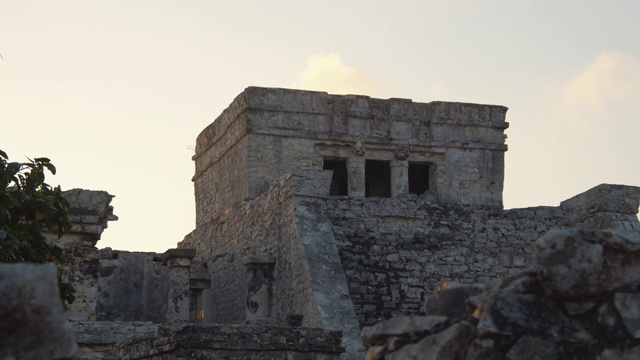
top-left (162, 249), bottom-right (196, 323)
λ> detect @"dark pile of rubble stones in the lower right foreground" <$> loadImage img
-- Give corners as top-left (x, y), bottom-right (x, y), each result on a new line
top-left (361, 230), bottom-right (640, 360)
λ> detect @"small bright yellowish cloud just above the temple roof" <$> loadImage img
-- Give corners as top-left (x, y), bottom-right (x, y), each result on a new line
top-left (292, 54), bottom-right (374, 95)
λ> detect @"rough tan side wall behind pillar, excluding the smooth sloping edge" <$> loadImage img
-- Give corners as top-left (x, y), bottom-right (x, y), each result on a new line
top-left (179, 174), bottom-right (320, 326)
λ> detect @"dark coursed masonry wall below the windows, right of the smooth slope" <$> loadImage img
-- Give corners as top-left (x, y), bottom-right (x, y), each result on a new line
top-left (327, 195), bottom-right (568, 326)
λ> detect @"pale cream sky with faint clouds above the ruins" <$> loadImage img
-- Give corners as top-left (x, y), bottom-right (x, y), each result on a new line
top-left (0, 0), bottom-right (640, 252)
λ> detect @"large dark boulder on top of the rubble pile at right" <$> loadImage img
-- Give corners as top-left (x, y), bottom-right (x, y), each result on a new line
top-left (534, 229), bottom-right (640, 299)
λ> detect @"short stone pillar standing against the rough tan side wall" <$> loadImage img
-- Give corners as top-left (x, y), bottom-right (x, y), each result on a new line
top-left (244, 255), bottom-right (276, 321)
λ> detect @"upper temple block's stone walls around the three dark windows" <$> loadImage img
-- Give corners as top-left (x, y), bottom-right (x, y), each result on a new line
top-left (194, 87), bottom-right (508, 226)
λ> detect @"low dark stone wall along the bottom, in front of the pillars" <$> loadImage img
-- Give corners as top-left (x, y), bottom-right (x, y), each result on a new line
top-left (72, 321), bottom-right (344, 360)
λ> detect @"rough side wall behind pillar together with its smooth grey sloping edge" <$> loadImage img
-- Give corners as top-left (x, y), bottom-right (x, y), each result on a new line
top-left (179, 171), bottom-right (364, 359)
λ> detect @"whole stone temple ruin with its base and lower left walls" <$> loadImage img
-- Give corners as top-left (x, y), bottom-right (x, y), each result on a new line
top-left (2, 87), bottom-right (640, 359)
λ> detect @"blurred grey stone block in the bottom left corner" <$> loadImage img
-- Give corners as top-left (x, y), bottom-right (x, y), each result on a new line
top-left (0, 263), bottom-right (77, 360)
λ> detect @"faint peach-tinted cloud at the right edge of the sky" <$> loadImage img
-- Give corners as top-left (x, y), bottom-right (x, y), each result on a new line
top-left (562, 51), bottom-right (640, 110)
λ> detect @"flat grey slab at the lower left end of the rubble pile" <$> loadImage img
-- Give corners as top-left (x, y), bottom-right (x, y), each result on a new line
top-left (360, 316), bottom-right (449, 345)
